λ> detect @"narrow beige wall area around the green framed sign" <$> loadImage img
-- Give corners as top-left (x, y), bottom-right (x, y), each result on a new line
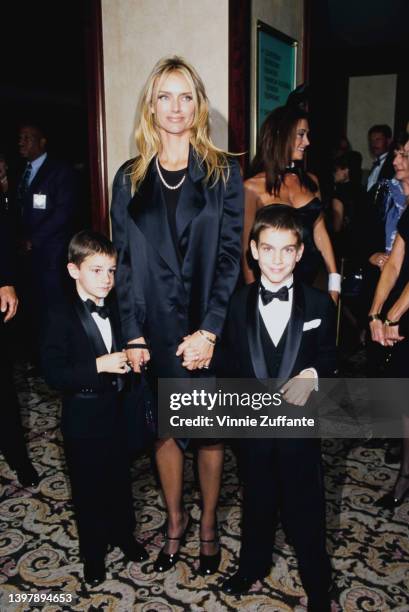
top-left (250, 0), bottom-right (304, 153)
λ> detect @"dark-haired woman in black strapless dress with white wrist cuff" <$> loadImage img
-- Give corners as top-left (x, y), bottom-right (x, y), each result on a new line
top-left (243, 106), bottom-right (341, 302)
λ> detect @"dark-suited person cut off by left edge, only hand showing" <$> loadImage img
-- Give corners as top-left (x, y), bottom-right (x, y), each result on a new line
top-left (0, 212), bottom-right (39, 487)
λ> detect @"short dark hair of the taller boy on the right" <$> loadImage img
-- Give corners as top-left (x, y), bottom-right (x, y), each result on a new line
top-left (250, 204), bottom-right (303, 247)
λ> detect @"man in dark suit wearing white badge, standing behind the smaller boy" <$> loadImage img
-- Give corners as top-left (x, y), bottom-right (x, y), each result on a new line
top-left (16, 124), bottom-right (78, 358)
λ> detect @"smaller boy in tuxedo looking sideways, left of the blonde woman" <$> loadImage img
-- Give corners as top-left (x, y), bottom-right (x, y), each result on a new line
top-left (43, 231), bottom-right (148, 585)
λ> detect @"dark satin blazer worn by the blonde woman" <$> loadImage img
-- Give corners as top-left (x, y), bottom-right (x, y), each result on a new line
top-left (111, 148), bottom-right (243, 377)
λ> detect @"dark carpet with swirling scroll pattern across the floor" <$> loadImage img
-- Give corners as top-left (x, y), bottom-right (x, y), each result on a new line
top-left (0, 373), bottom-right (409, 612)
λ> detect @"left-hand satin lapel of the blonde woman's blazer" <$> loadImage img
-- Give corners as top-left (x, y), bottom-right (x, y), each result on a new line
top-left (129, 162), bottom-right (182, 280)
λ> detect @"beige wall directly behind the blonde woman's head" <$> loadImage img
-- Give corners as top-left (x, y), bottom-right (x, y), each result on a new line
top-left (102, 0), bottom-right (228, 187)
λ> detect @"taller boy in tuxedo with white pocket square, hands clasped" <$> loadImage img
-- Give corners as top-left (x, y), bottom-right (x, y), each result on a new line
top-left (222, 204), bottom-right (335, 612)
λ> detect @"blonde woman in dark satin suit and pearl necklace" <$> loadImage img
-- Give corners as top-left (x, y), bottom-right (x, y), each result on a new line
top-left (111, 57), bottom-right (243, 574)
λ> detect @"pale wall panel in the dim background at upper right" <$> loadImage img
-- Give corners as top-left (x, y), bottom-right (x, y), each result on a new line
top-left (347, 74), bottom-right (397, 169)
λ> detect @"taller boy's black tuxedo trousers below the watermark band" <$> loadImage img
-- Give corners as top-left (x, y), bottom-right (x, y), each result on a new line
top-left (239, 438), bottom-right (331, 599)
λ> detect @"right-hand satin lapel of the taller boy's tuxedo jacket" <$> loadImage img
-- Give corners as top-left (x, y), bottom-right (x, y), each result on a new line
top-left (278, 282), bottom-right (305, 382)
